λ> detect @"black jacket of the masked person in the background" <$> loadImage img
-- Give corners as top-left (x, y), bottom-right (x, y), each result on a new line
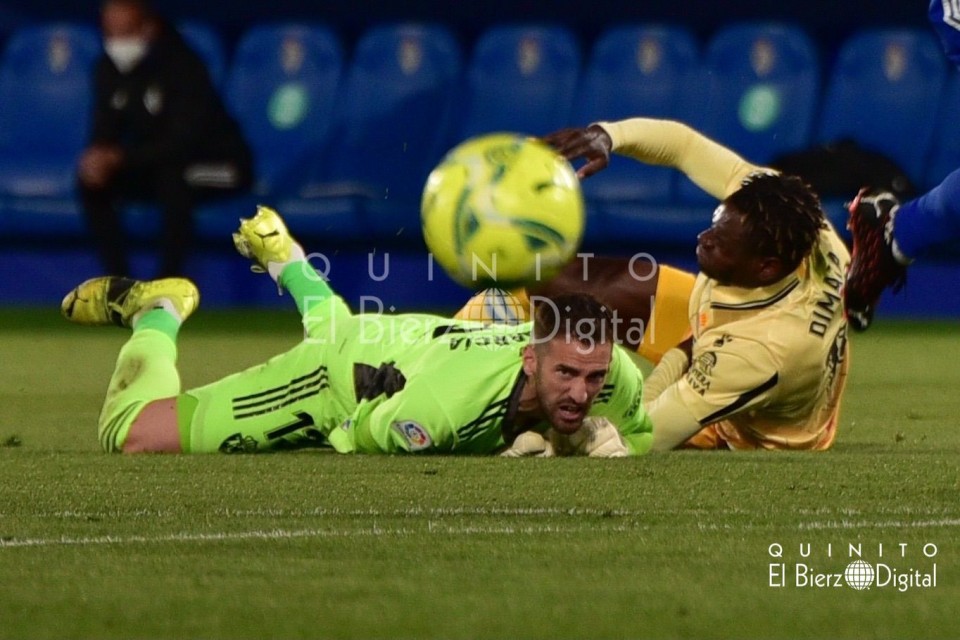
top-left (91, 26), bottom-right (251, 170)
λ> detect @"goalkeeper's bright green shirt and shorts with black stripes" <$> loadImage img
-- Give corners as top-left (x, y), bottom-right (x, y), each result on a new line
top-left (182, 298), bottom-right (652, 454)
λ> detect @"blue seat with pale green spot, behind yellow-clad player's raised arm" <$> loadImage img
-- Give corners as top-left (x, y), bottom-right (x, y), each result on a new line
top-left (680, 23), bottom-right (820, 203)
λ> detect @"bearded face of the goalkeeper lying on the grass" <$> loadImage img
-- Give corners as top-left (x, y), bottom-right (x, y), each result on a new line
top-left (523, 336), bottom-right (613, 433)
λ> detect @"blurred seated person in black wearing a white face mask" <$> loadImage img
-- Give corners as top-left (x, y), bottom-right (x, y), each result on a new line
top-left (77, 0), bottom-right (253, 275)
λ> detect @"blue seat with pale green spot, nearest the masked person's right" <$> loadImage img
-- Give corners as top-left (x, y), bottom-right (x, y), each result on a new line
top-left (225, 23), bottom-right (343, 195)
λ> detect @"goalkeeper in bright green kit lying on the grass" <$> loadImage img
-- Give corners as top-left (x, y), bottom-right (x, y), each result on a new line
top-left (62, 207), bottom-right (652, 457)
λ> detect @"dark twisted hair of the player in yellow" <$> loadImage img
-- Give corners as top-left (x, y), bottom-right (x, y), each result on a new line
top-left (724, 172), bottom-right (826, 271)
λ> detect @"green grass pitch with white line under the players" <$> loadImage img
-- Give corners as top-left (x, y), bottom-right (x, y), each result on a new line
top-left (0, 310), bottom-right (960, 638)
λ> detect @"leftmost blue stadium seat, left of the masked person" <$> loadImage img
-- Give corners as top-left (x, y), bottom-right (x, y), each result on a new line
top-left (0, 23), bottom-right (101, 237)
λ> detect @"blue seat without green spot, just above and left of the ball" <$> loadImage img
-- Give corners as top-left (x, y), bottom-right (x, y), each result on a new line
top-left (287, 23), bottom-right (462, 245)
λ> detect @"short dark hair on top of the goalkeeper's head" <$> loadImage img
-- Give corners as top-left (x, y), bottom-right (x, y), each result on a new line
top-left (533, 293), bottom-right (615, 345)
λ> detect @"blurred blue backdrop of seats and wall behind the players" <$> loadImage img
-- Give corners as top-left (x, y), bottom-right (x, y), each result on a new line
top-left (0, 0), bottom-right (960, 316)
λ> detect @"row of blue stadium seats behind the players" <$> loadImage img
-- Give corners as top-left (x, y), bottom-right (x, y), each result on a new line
top-left (0, 23), bottom-right (960, 251)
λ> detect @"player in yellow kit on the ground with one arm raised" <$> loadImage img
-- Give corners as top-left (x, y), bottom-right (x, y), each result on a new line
top-left (492, 118), bottom-right (850, 450)
